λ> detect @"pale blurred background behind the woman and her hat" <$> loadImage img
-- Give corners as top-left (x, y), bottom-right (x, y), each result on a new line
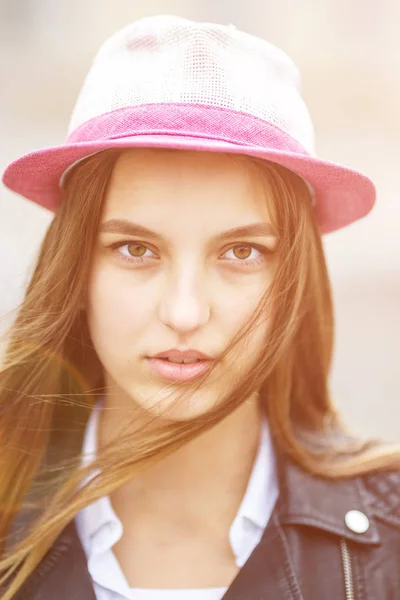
top-left (0, 0), bottom-right (400, 441)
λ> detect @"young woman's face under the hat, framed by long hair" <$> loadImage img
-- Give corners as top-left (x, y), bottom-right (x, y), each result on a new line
top-left (87, 149), bottom-right (277, 420)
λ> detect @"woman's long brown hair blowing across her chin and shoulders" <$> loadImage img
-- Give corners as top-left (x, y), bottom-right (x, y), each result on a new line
top-left (0, 150), bottom-right (400, 600)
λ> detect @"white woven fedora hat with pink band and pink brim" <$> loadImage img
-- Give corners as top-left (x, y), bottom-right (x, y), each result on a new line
top-left (3, 16), bottom-right (375, 233)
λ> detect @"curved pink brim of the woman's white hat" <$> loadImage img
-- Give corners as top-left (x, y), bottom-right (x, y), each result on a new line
top-left (3, 107), bottom-right (376, 233)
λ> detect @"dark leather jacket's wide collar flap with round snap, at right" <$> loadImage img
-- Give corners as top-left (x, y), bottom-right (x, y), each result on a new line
top-left (277, 453), bottom-right (380, 545)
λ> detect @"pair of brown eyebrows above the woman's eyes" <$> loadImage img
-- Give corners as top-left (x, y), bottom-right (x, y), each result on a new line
top-left (99, 219), bottom-right (276, 241)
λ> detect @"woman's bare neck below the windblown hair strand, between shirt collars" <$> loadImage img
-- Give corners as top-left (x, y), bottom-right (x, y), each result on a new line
top-left (99, 395), bottom-right (262, 531)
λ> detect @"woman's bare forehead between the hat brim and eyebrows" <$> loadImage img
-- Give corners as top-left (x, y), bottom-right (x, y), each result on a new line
top-left (104, 149), bottom-right (268, 225)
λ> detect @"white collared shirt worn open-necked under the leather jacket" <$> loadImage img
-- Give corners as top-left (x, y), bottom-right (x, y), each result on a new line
top-left (75, 402), bottom-right (278, 600)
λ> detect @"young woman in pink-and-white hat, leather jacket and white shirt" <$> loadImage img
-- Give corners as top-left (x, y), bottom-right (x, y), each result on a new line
top-left (0, 16), bottom-right (400, 600)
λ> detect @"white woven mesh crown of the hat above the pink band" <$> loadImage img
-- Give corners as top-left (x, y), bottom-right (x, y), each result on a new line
top-left (68, 16), bottom-right (315, 156)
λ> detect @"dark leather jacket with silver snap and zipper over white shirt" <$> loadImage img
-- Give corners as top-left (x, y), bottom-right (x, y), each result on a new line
top-left (7, 452), bottom-right (400, 600)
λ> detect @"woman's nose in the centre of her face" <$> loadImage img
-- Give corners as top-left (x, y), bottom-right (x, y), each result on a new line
top-left (160, 263), bottom-right (210, 335)
